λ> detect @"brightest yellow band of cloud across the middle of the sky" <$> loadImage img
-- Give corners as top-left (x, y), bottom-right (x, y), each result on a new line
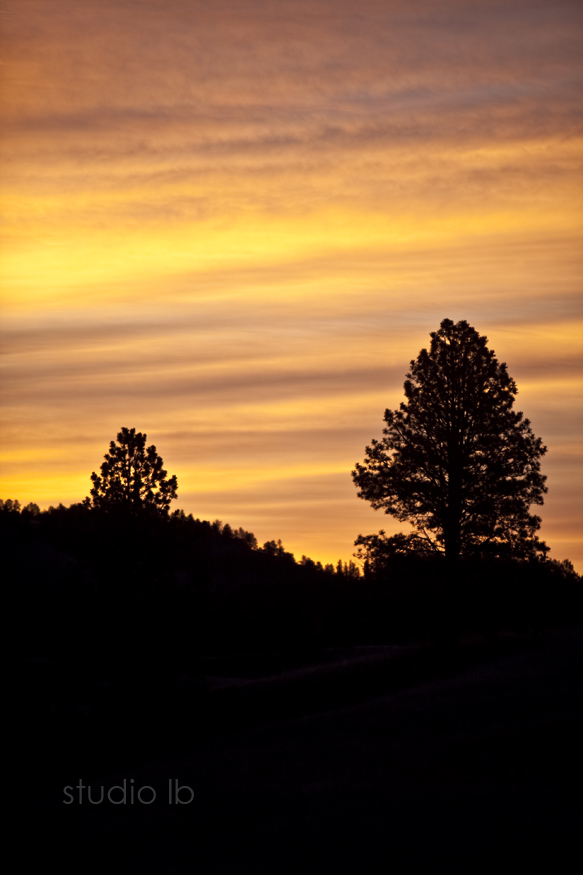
top-left (3, 203), bottom-right (575, 310)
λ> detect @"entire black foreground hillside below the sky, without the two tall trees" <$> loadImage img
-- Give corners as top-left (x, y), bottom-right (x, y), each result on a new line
top-left (0, 506), bottom-right (583, 875)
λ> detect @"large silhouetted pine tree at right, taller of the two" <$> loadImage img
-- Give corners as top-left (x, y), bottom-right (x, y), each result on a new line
top-left (352, 319), bottom-right (548, 562)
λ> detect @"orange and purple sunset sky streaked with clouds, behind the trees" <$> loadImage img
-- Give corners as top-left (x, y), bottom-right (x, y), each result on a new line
top-left (0, 0), bottom-right (583, 572)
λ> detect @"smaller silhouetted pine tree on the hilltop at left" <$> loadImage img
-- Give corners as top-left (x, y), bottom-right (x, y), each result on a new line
top-left (86, 428), bottom-right (178, 516)
